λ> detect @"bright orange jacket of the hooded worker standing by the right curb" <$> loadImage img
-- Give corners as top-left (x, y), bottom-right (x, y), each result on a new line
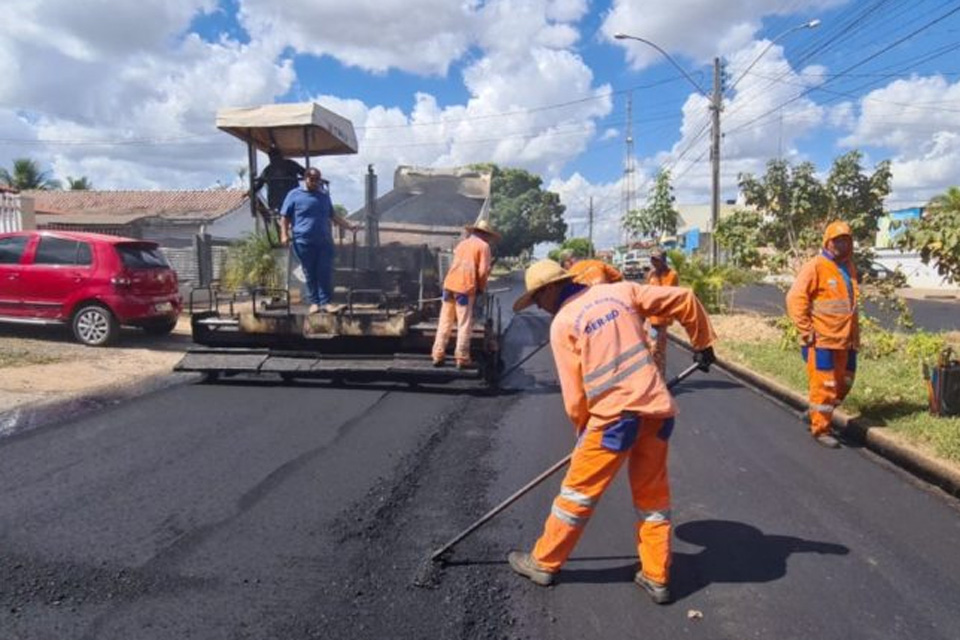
top-left (787, 255), bottom-right (860, 349)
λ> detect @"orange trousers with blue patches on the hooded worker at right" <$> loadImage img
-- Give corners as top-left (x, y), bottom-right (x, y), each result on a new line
top-left (801, 347), bottom-right (857, 436)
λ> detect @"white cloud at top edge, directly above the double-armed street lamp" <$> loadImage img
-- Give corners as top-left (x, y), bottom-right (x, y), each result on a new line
top-left (601, 0), bottom-right (848, 69)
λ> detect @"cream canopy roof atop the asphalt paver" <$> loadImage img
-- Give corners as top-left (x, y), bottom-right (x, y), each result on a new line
top-left (217, 102), bottom-right (357, 158)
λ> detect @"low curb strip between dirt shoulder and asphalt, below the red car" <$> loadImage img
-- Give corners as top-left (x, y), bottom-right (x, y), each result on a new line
top-left (0, 372), bottom-right (201, 438)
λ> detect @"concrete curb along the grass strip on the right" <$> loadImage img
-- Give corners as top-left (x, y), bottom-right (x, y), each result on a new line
top-left (668, 334), bottom-right (960, 498)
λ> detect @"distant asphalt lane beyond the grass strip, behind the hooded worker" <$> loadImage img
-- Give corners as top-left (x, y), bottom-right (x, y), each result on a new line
top-left (733, 284), bottom-right (960, 331)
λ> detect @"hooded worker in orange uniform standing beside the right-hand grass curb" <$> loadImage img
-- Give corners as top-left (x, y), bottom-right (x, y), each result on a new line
top-left (787, 221), bottom-right (860, 449)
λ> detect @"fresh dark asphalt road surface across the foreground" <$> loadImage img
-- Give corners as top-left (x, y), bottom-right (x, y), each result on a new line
top-left (0, 286), bottom-right (960, 640)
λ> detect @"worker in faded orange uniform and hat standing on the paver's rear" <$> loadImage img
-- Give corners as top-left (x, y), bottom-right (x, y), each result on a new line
top-left (433, 220), bottom-right (500, 369)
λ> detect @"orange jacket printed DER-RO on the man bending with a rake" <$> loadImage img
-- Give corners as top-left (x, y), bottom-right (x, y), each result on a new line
top-left (550, 282), bottom-right (716, 431)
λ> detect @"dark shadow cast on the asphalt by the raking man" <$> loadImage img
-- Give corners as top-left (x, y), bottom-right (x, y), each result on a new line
top-left (560, 520), bottom-right (850, 600)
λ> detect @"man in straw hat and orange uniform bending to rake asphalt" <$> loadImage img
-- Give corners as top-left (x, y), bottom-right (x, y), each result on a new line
top-left (507, 260), bottom-right (716, 604)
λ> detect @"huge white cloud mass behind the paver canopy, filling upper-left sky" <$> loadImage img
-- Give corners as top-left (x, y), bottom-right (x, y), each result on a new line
top-left (0, 0), bottom-right (611, 206)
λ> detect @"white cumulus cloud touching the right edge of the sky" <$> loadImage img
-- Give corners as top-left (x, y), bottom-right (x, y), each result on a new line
top-left (841, 75), bottom-right (960, 201)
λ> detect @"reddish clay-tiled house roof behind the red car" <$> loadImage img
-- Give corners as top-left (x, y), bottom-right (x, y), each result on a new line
top-left (23, 189), bottom-right (247, 224)
